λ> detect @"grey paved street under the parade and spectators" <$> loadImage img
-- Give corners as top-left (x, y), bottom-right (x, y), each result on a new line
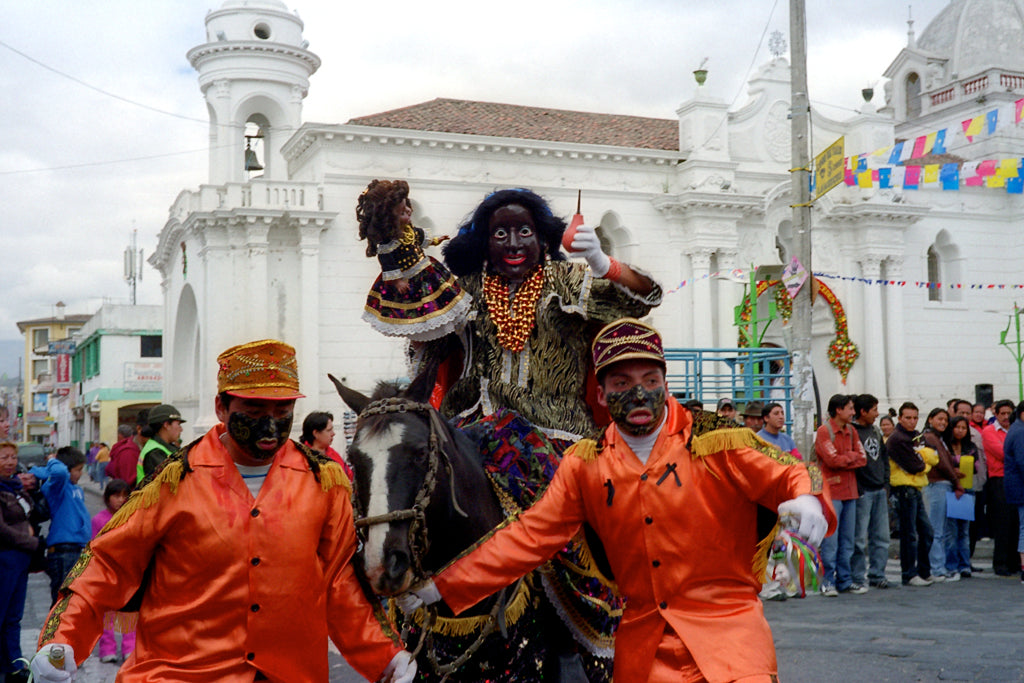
top-left (14, 475), bottom-right (1024, 683)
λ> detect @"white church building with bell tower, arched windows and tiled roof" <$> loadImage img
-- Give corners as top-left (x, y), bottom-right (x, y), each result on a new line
top-left (150, 0), bottom-right (1024, 431)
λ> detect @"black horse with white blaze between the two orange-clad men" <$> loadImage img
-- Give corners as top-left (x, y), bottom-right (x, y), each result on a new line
top-left (330, 371), bottom-right (610, 683)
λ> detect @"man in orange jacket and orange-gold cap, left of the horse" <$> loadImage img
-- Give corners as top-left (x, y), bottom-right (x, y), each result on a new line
top-left (32, 340), bottom-right (416, 683)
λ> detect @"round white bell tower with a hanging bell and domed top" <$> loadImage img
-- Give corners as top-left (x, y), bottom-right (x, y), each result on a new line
top-left (187, 0), bottom-right (321, 185)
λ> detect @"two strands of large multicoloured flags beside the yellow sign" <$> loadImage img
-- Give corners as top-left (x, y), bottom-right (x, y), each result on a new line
top-left (823, 98), bottom-right (1024, 195)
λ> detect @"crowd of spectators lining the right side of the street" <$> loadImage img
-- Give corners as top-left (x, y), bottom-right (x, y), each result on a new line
top-left (717, 394), bottom-right (1024, 599)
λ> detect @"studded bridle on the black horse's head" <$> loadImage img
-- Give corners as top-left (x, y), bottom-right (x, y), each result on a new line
top-left (354, 396), bottom-right (469, 581)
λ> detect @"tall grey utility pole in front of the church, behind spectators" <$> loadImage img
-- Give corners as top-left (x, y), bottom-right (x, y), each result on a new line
top-left (790, 0), bottom-right (816, 461)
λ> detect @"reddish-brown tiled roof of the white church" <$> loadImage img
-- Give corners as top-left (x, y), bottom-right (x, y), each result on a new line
top-left (348, 98), bottom-right (679, 151)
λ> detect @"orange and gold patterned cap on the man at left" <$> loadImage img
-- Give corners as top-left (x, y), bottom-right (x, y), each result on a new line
top-left (217, 339), bottom-right (305, 400)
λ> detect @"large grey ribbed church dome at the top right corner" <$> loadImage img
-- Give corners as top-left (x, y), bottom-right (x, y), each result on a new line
top-left (918, 0), bottom-right (1024, 79)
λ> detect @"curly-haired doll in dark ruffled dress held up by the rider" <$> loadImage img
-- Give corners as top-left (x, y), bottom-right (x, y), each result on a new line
top-left (355, 180), bottom-right (471, 342)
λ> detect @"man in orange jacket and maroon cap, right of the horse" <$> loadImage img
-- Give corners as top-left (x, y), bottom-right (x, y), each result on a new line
top-left (400, 318), bottom-right (835, 682)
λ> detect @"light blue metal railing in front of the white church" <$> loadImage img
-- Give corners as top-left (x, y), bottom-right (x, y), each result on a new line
top-left (665, 348), bottom-right (794, 428)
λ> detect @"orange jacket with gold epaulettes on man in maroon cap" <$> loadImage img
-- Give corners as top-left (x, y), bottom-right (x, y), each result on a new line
top-left (435, 398), bottom-right (836, 683)
